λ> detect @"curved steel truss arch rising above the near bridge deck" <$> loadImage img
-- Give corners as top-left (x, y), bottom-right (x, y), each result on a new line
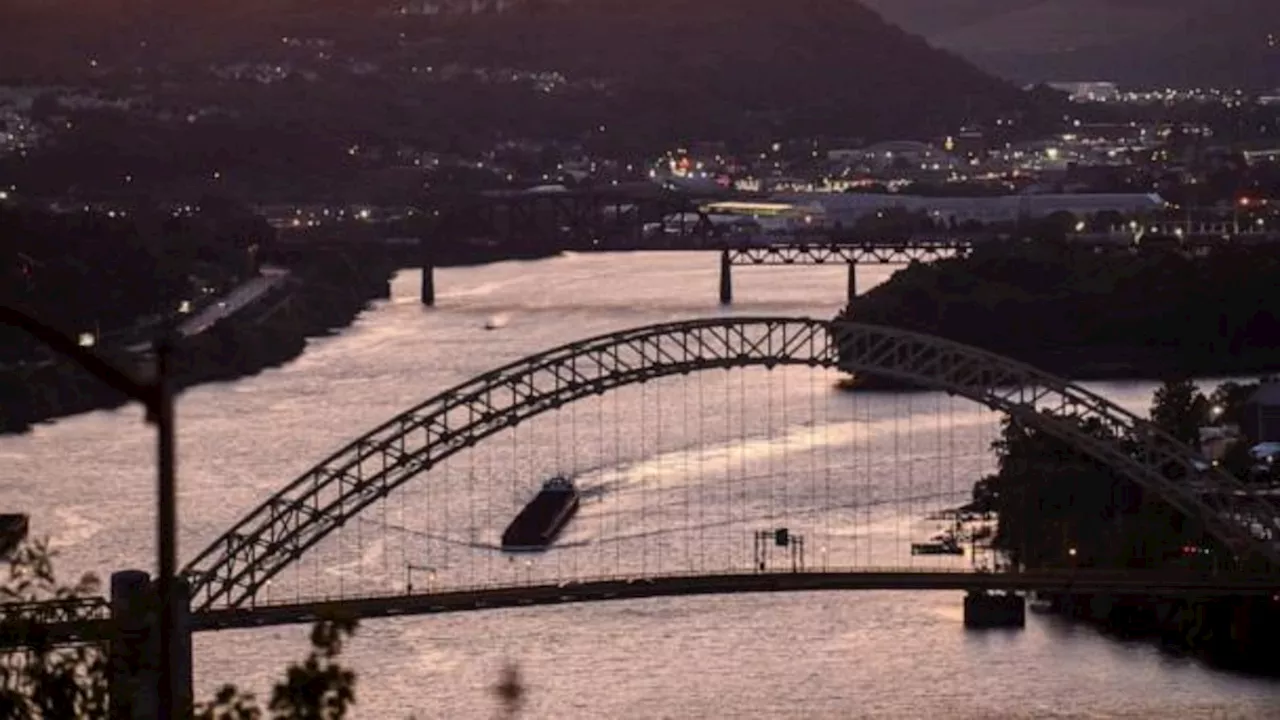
top-left (183, 318), bottom-right (1280, 611)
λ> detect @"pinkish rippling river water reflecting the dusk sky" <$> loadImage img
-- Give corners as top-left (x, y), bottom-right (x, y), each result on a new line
top-left (0, 254), bottom-right (1280, 719)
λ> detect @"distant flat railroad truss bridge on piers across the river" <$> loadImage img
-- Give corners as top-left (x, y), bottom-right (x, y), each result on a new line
top-left (274, 183), bottom-right (1280, 306)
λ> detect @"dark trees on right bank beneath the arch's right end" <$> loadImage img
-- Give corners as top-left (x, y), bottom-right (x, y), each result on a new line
top-left (968, 380), bottom-right (1280, 673)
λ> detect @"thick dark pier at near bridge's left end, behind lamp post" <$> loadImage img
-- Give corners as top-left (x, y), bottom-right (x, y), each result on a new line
top-left (108, 570), bottom-right (193, 720)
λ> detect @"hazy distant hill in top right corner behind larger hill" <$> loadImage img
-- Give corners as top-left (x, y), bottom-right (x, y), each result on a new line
top-left (864, 0), bottom-right (1280, 87)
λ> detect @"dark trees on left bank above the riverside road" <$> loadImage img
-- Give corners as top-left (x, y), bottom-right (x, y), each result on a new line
top-left (0, 197), bottom-right (273, 363)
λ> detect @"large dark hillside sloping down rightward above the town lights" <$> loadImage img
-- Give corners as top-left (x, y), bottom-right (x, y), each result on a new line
top-left (0, 0), bottom-right (1062, 200)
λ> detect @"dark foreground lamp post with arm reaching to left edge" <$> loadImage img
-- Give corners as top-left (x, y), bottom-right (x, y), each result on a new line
top-left (0, 305), bottom-right (186, 719)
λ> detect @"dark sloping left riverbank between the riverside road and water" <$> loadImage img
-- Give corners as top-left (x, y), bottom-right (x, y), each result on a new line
top-left (0, 251), bottom-right (397, 434)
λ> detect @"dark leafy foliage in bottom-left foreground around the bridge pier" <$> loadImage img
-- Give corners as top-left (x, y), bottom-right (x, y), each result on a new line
top-left (0, 542), bottom-right (356, 720)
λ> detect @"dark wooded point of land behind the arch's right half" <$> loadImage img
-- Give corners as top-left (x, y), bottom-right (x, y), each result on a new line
top-left (846, 242), bottom-right (1280, 378)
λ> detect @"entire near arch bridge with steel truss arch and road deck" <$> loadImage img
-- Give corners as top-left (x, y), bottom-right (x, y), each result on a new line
top-left (5, 318), bottom-right (1280, 642)
